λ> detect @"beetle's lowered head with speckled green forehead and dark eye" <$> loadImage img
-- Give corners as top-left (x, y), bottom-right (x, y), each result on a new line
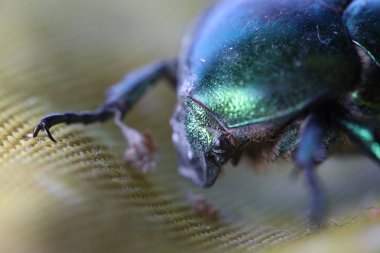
top-left (171, 97), bottom-right (236, 187)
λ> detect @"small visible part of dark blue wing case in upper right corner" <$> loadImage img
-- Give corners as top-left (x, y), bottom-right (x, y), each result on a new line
top-left (343, 0), bottom-right (380, 67)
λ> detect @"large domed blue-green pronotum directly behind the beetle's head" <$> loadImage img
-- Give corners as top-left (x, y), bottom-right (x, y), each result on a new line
top-left (180, 0), bottom-right (360, 128)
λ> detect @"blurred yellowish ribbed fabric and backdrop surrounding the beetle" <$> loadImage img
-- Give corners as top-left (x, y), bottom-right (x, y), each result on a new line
top-left (0, 0), bottom-right (380, 252)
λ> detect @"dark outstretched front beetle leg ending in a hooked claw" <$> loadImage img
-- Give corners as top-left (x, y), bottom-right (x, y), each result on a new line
top-left (33, 60), bottom-right (177, 142)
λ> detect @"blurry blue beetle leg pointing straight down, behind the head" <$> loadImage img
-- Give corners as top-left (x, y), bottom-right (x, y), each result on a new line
top-left (295, 113), bottom-right (327, 227)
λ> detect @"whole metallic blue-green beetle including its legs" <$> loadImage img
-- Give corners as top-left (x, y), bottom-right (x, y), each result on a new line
top-left (33, 0), bottom-right (380, 225)
